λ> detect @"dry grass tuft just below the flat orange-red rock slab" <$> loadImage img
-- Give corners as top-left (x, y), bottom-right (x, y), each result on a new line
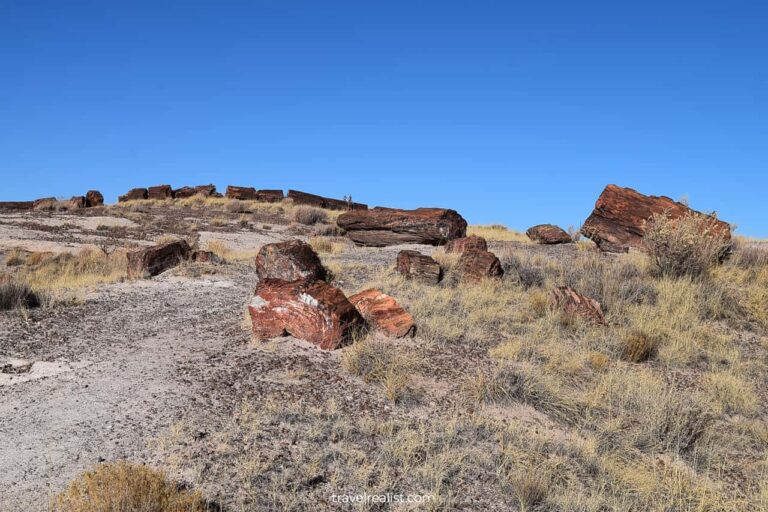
top-left (342, 336), bottom-right (418, 402)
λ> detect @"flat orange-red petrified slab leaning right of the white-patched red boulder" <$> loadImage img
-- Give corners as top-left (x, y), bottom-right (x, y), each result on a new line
top-left (349, 288), bottom-right (416, 338)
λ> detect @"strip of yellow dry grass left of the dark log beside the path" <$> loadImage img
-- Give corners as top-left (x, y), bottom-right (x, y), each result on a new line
top-left (18, 247), bottom-right (128, 291)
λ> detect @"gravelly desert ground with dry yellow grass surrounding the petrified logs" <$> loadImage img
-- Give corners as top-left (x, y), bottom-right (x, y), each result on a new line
top-left (0, 197), bottom-right (768, 511)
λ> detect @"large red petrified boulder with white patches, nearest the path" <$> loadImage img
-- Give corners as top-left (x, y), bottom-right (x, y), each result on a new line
top-left (248, 279), bottom-right (365, 350)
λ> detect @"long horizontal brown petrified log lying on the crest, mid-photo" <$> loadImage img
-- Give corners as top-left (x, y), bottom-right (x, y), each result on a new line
top-left (336, 207), bottom-right (467, 247)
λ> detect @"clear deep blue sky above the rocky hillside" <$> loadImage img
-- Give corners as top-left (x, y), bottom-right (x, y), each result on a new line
top-left (0, 0), bottom-right (768, 237)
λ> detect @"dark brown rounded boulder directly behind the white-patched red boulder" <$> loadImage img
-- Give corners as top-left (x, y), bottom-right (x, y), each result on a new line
top-left (256, 240), bottom-right (327, 281)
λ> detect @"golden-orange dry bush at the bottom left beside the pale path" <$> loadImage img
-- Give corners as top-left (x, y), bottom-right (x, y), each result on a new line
top-left (51, 461), bottom-right (209, 512)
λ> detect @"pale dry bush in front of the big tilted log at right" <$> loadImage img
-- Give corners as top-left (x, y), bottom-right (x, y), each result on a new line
top-left (643, 213), bottom-right (731, 277)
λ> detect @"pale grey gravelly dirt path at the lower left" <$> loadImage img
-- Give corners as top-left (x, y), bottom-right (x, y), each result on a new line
top-left (0, 267), bottom-right (250, 511)
